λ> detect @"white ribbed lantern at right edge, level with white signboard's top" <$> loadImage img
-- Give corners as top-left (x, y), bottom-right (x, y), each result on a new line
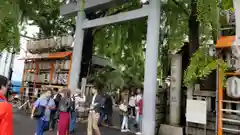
top-left (226, 76), bottom-right (240, 98)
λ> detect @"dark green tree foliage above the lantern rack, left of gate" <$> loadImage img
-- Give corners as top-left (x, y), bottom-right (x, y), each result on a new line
top-left (20, 0), bottom-right (75, 38)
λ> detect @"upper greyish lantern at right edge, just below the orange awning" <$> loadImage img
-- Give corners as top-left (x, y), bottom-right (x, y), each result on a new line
top-left (226, 52), bottom-right (240, 71)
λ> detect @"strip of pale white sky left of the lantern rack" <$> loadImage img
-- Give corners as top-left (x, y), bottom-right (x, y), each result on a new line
top-left (12, 26), bottom-right (38, 81)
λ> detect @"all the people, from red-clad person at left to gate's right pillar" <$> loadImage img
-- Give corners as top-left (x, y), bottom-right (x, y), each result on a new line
top-left (0, 75), bottom-right (143, 135)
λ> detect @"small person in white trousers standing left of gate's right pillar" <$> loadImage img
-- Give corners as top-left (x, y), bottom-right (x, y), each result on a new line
top-left (119, 100), bottom-right (129, 132)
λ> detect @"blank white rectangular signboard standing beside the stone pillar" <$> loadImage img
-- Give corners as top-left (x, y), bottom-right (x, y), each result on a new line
top-left (186, 99), bottom-right (207, 125)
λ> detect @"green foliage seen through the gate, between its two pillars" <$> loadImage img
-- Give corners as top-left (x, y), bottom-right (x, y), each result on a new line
top-left (94, 0), bottom-right (147, 85)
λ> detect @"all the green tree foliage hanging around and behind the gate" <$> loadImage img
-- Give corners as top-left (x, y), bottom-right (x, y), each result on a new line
top-left (0, 0), bottom-right (232, 86)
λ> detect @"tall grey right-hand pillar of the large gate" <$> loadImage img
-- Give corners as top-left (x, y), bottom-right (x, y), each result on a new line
top-left (142, 0), bottom-right (160, 135)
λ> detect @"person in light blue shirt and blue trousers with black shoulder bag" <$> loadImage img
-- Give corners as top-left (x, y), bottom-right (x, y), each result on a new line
top-left (31, 89), bottom-right (56, 135)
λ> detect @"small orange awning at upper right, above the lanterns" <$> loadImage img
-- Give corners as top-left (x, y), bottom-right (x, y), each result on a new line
top-left (216, 36), bottom-right (235, 48)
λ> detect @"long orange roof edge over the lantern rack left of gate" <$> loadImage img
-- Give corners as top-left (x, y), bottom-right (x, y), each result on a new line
top-left (19, 52), bottom-right (72, 60)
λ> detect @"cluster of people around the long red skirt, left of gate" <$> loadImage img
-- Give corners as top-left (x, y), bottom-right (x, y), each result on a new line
top-left (31, 89), bottom-right (86, 135)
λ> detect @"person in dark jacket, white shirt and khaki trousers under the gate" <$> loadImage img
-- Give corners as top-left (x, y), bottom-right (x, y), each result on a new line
top-left (87, 86), bottom-right (101, 135)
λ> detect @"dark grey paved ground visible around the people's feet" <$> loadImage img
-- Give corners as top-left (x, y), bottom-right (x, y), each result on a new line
top-left (14, 110), bottom-right (133, 135)
